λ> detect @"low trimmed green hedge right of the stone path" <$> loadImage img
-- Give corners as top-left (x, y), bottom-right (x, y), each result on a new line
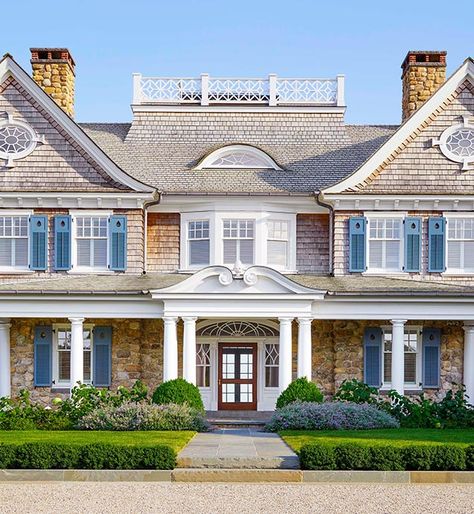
top-left (299, 443), bottom-right (474, 471)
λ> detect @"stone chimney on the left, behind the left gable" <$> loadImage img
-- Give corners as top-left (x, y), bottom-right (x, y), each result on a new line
top-left (30, 48), bottom-right (75, 117)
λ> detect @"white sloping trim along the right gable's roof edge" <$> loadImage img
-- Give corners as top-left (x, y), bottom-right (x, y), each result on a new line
top-left (323, 58), bottom-right (474, 194)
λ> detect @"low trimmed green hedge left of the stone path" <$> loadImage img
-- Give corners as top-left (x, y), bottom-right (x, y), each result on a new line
top-left (0, 442), bottom-right (176, 469)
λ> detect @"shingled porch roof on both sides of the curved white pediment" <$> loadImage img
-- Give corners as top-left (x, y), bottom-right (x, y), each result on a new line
top-left (0, 273), bottom-right (474, 296)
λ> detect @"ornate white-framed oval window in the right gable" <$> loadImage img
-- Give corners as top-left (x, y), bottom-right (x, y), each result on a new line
top-left (431, 116), bottom-right (474, 171)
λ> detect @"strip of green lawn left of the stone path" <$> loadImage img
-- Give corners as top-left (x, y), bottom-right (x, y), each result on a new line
top-left (0, 430), bottom-right (195, 453)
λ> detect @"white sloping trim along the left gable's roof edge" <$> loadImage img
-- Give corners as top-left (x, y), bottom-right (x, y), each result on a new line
top-left (0, 54), bottom-right (153, 193)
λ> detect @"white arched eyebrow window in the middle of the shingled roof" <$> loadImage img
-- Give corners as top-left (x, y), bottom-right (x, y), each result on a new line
top-left (197, 145), bottom-right (280, 170)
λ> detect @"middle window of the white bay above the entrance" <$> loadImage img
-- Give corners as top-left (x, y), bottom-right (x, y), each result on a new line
top-left (223, 220), bottom-right (254, 265)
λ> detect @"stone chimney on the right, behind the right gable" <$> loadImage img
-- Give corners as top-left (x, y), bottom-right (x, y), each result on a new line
top-left (402, 50), bottom-right (446, 121)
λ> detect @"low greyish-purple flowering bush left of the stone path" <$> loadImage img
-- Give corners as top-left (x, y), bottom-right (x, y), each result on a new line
top-left (78, 402), bottom-right (207, 432)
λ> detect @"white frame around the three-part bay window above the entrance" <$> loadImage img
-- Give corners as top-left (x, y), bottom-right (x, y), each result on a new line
top-left (180, 210), bottom-right (296, 274)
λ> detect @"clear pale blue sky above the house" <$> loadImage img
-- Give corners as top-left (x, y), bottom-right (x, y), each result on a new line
top-left (0, 0), bottom-right (474, 124)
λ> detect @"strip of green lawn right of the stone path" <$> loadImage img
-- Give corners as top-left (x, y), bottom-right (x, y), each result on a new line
top-left (279, 428), bottom-right (474, 451)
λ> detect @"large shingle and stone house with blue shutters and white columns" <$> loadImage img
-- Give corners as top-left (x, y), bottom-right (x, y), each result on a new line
top-left (0, 48), bottom-right (474, 410)
